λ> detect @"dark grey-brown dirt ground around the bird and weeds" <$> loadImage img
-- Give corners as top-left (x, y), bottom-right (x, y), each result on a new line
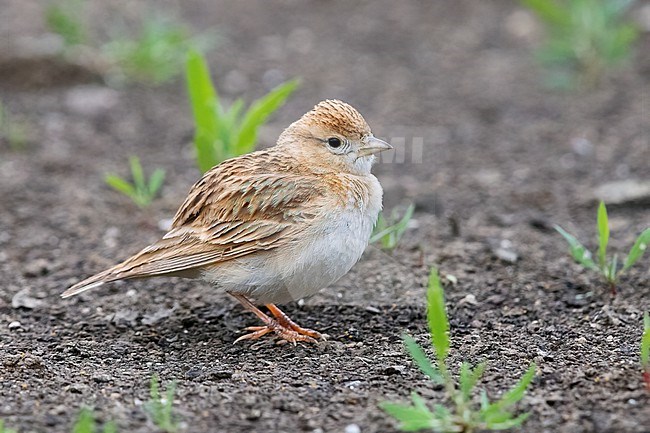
top-left (0, 0), bottom-right (650, 433)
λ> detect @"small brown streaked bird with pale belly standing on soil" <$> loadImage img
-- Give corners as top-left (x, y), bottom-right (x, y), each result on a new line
top-left (61, 99), bottom-right (392, 345)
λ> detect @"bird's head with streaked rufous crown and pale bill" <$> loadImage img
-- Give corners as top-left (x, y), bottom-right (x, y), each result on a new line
top-left (278, 99), bottom-right (392, 174)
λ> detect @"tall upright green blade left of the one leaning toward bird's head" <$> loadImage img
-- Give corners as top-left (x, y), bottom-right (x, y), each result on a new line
top-left (185, 49), bottom-right (220, 173)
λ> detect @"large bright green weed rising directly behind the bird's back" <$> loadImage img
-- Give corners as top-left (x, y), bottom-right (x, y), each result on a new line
top-left (185, 50), bottom-right (298, 173)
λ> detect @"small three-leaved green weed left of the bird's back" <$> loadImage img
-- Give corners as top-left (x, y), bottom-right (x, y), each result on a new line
top-left (105, 156), bottom-right (165, 208)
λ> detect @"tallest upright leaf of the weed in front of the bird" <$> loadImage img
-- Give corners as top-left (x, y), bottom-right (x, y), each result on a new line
top-left (427, 268), bottom-right (449, 365)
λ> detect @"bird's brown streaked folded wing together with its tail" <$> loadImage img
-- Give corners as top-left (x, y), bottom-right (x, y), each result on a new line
top-left (63, 155), bottom-right (324, 297)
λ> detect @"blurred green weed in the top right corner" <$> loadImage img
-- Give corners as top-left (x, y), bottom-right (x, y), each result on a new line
top-left (521, 0), bottom-right (638, 88)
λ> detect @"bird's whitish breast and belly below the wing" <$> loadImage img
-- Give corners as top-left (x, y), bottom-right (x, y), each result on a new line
top-left (199, 175), bottom-right (382, 303)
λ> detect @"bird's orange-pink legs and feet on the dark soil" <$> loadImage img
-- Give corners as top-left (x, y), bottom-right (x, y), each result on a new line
top-left (228, 292), bottom-right (325, 344)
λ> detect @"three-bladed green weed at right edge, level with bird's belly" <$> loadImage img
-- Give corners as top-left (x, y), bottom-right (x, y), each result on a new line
top-left (555, 201), bottom-right (650, 294)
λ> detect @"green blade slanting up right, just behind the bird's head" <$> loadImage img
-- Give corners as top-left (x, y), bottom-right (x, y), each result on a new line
top-left (235, 80), bottom-right (300, 154)
